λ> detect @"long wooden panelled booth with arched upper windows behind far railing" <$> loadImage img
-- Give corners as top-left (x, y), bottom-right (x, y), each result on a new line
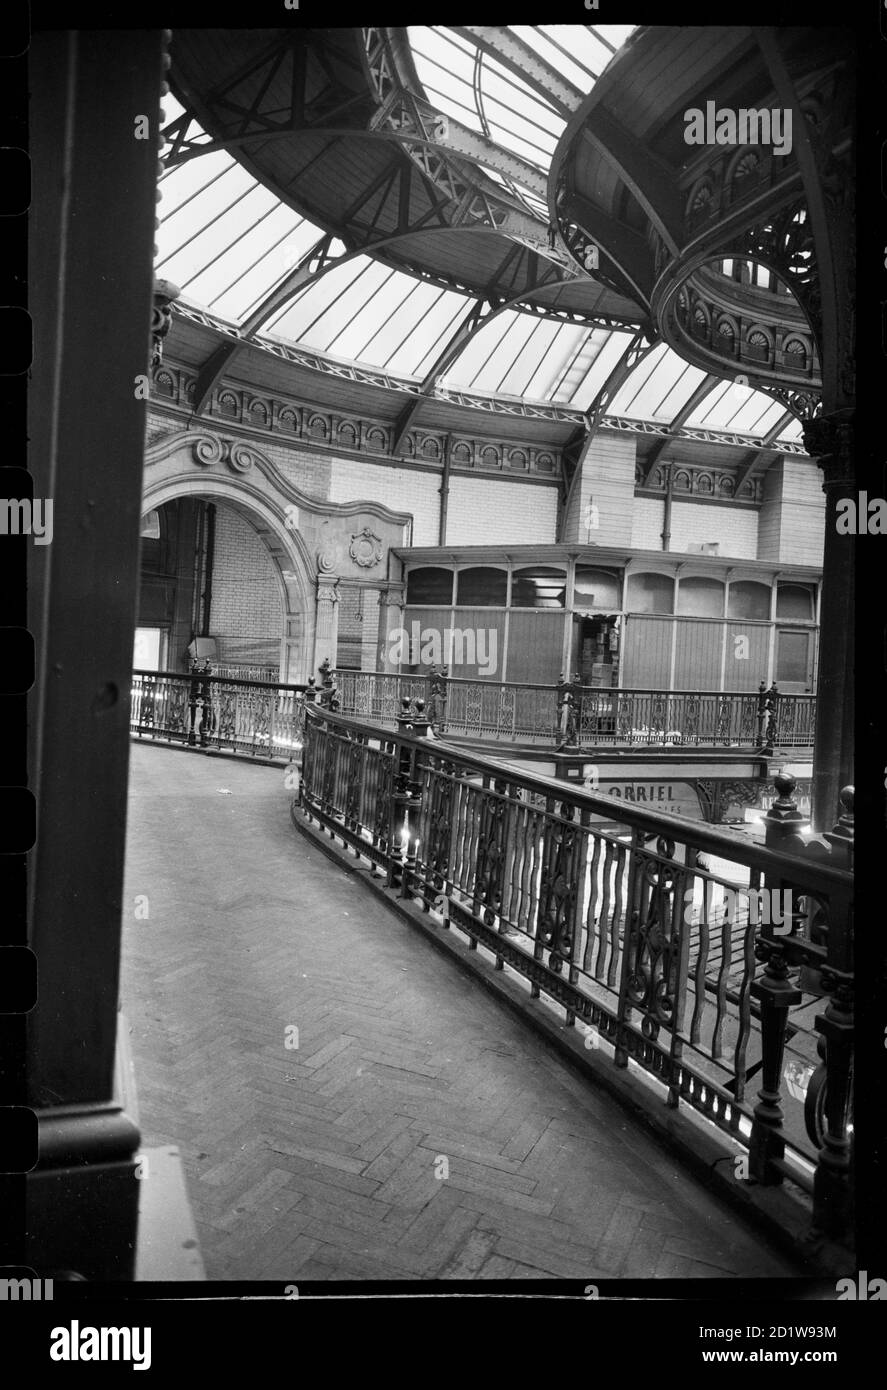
top-left (392, 545), bottom-right (820, 695)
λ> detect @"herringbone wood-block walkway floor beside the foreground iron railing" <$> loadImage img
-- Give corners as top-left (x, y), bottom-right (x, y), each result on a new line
top-left (121, 744), bottom-right (802, 1280)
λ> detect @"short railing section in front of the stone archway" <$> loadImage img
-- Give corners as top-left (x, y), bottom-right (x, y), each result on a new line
top-left (129, 671), bottom-right (306, 759)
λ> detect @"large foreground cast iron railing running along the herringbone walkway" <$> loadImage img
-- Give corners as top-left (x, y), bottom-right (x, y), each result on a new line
top-left (303, 706), bottom-right (854, 1240)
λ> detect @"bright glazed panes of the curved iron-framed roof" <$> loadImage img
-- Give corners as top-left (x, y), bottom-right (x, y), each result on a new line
top-left (156, 25), bottom-right (801, 441)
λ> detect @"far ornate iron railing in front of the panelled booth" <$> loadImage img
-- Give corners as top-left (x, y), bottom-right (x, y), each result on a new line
top-left (338, 671), bottom-right (816, 751)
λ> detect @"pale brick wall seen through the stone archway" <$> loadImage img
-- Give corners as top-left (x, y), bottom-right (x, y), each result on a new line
top-left (210, 505), bottom-right (284, 666)
